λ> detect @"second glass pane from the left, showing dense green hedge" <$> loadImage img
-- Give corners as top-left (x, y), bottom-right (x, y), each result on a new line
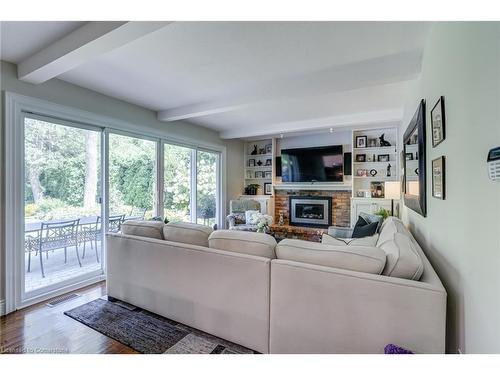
top-left (109, 133), bottom-right (156, 220)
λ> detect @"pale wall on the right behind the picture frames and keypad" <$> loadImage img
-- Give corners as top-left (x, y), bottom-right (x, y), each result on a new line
top-left (400, 22), bottom-right (500, 353)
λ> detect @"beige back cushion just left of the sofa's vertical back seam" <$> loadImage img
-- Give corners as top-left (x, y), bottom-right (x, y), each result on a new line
top-left (208, 230), bottom-right (276, 259)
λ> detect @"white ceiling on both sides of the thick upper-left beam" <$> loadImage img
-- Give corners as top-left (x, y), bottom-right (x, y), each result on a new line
top-left (1, 22), bottom-right (429, 138)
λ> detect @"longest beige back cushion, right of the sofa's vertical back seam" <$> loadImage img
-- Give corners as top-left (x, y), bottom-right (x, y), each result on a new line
top-left (276, 239), bottom-right (385, 274)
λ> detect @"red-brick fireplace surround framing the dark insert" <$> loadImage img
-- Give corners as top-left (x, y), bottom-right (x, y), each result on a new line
top-left (274, 189), bottom-right (351, 227)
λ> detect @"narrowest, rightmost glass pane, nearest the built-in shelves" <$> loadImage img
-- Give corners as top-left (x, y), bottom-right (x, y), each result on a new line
top-left (196, 151), bottom-right (219, 226)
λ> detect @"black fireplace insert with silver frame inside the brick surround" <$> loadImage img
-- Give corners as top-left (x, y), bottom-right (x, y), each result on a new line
top-left (290, 197), bottom-right (332, 227)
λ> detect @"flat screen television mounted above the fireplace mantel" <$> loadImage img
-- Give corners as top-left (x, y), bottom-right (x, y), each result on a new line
top-left (281, 146), bottom-right (344, 182)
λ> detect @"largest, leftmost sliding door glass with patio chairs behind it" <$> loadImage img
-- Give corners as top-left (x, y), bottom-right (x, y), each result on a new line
top-left (21, 116), bottom-right (103, 298)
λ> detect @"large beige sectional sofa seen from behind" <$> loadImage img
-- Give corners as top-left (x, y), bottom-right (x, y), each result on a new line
top-left (107, 218), bottom-right (446, 353)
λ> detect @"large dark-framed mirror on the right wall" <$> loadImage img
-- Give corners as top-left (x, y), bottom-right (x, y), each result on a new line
top-left (403, 99), bottom-right (427, 217)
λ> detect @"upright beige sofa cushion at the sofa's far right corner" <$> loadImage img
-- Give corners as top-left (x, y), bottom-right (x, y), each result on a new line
top-left (377, 217), bottom-right (424, 280)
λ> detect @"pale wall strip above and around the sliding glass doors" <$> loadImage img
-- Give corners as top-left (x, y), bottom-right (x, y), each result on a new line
top-left (0, 61), bottom-right (243, 301)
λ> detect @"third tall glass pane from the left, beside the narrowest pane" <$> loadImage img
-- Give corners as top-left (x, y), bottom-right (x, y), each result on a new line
top-left (163, 144), bottom-right (193, 221)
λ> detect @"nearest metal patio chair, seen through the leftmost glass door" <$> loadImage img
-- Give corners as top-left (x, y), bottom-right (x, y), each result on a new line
top-left (37, 219), bottom-right (82, 277)
